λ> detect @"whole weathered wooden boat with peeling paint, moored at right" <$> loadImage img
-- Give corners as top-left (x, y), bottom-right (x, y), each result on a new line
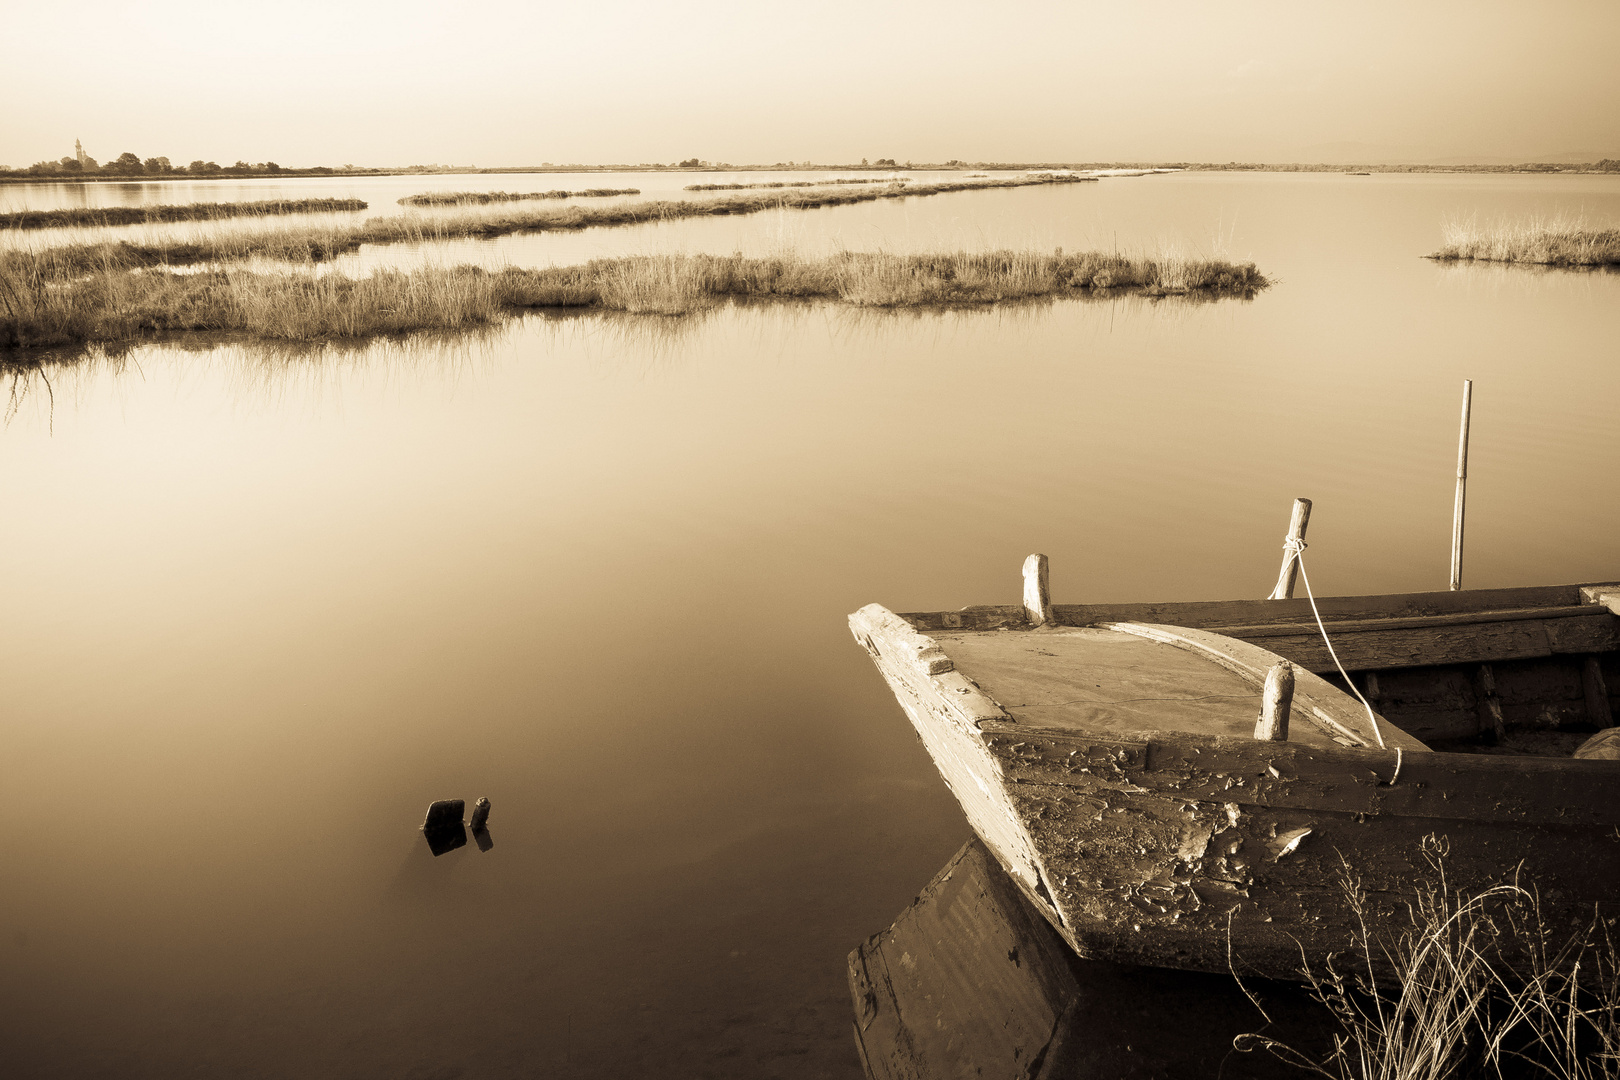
top-left (849, 555), bottom-right (1620, 978)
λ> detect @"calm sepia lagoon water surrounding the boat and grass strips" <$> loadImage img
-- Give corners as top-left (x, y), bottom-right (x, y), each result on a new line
top-left (0, 173), bottom-right (1620, 1078)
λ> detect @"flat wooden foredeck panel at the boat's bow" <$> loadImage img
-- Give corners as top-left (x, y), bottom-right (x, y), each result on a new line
top-left (928, 628), bottom-right (1354, 746)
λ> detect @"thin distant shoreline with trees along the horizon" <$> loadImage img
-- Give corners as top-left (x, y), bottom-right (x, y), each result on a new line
top-left (0, 159), bottom-right (1620, 185)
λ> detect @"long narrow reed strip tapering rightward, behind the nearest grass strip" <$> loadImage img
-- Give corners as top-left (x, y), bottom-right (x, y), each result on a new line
top-left (6, 175), bottom-right (1082, 274)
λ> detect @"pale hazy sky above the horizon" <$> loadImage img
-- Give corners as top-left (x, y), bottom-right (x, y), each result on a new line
top-left (0, 0), bottom-right (1620, 167)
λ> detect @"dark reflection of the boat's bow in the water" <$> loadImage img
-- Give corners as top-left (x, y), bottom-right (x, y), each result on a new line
top-left (849, 837), bottom-right (1327, 1080)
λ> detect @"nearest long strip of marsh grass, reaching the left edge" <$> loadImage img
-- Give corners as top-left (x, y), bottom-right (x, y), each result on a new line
top-left (0, 251), bottom-right (1267, 348)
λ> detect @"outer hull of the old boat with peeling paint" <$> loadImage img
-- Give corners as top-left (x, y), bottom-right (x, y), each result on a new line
top-left (852, 609), bottom-right (1620, 978)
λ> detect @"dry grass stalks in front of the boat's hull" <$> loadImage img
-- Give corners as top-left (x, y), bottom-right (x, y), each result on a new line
top-left (1233, 836), bottom-right (1620, 1080)
